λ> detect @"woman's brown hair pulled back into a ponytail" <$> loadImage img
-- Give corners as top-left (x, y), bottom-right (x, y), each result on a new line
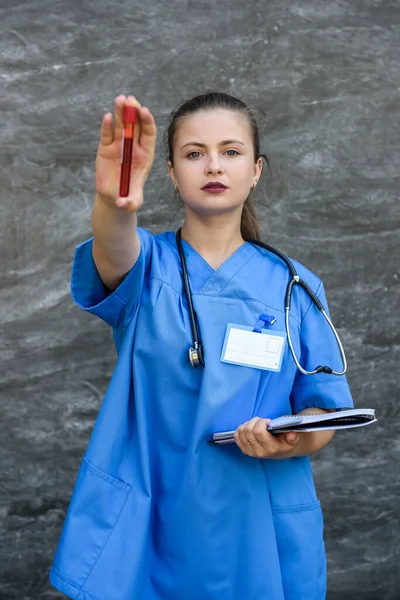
top-left (164, 92), bottom-right (270, 240)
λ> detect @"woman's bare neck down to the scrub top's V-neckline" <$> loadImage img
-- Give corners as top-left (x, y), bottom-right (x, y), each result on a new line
top-left (182, 209), bottom-right (244, 269)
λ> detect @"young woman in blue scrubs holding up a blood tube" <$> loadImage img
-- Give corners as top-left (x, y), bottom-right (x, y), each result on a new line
top-left (50, 93), bottom-right (353, 600)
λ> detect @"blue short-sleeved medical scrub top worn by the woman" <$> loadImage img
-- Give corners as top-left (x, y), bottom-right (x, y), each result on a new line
top-left (50, 229), bottom-right (353, 600)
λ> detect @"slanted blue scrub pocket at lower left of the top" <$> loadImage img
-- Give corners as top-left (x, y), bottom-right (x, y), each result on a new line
top-left (53, 455), bottom-right (131, 588)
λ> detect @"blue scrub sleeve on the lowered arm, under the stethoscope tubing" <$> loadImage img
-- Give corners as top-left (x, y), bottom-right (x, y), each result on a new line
top-left (290, 282), bottom-right (354, 414)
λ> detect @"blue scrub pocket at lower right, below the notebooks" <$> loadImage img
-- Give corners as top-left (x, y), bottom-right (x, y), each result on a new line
top-left (272, 500), bottom-right (327, 600)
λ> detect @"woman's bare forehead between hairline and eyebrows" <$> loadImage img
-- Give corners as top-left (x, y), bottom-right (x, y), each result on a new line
top-left (175, 109), bottom-right (252, 145)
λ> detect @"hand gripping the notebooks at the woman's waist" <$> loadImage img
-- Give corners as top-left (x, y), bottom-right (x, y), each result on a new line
top-left (234, 417), bottom-right (302, 458)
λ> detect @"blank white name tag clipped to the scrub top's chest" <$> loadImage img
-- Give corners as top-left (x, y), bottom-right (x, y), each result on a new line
top-left (221, 323), bottom-right (286, 371)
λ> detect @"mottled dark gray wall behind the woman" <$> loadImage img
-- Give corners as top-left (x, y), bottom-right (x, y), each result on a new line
top-left (0, 0), bottom-right (400, 600)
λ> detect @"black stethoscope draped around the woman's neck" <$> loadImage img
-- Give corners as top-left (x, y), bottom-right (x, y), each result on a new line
top-left (176, 229), bottom-right (347, 375)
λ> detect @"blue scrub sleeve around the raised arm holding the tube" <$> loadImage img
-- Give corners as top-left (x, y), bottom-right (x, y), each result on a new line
top-left (71, 228), bottom-right (152, 329)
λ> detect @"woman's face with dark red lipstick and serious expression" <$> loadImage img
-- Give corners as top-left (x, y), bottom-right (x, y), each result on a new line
top-left (168, 109), bottom-right (262, 216)
